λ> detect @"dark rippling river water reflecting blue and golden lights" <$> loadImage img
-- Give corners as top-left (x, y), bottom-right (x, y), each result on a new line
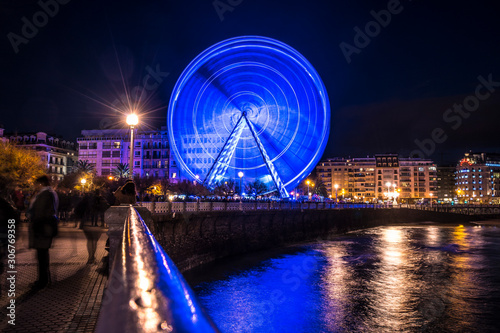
top-left (187, 226), bottom-right (500, 333)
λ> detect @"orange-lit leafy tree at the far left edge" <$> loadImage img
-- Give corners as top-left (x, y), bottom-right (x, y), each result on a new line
top-left (0, 142), bottom-right (46, 191)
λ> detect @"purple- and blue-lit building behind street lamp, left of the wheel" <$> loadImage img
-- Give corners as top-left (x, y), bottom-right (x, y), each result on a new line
top-left (77, 127), bottom-right (179, 180)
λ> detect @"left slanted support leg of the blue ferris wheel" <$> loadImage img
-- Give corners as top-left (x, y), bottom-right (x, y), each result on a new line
top-left (203, 114), bottom-right (245, 187)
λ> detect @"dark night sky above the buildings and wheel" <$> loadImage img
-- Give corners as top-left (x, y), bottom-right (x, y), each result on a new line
top-left (0, 0), bottom-right (500, 163)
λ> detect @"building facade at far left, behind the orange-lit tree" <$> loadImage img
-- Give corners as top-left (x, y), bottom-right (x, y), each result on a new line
top-left (0, 130), bottom-right (78, 182)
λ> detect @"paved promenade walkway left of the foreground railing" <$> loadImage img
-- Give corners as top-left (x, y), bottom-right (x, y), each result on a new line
top-left (0, 224), bottom-right (107, 333)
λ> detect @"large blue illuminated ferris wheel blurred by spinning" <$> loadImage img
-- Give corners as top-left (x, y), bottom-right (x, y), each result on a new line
top-left (167, 36), bottom-right (330, 197)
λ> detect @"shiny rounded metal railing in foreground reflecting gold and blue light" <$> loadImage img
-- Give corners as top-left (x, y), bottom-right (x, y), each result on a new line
top-left (96, 206), bottom-right (218, 333)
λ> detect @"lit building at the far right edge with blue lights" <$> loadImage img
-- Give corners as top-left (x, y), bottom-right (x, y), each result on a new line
top-left (455, 152), bottom-right (500, 203)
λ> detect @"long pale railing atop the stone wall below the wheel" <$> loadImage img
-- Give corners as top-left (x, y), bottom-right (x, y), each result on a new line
top-left (138, 201), bottom-right (382, 214)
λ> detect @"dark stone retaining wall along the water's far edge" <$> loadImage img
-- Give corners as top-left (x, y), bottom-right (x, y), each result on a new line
top-left (148, 209), bottom-right (484, 271)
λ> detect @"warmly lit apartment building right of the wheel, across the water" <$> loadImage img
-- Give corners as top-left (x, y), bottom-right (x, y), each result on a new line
top-left (316, 154), bottom-right (437, 202)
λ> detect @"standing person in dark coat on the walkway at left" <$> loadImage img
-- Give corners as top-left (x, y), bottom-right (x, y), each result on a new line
top-left (27, 176), bottom-right (59, 289)
